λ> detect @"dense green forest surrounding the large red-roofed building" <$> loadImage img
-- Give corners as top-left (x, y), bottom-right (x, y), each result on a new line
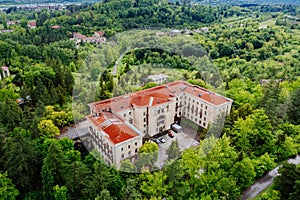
top-left (0, 0), bottom-right (300, 200)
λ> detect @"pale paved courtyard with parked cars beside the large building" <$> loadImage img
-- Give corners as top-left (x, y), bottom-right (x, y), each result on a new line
top-left (155, 119), bottom-right (199, 169)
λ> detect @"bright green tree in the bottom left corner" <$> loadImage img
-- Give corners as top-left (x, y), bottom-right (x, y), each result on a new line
top-left (0, 173), bottom-right (19, 200)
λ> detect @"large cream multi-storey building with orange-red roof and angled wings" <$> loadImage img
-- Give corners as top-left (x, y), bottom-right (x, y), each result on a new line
top-left (87, 81), bottom-right (233, 167)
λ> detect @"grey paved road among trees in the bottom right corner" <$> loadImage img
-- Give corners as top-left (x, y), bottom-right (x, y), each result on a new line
top-left (240, 155), bottom-right (300, 200)
